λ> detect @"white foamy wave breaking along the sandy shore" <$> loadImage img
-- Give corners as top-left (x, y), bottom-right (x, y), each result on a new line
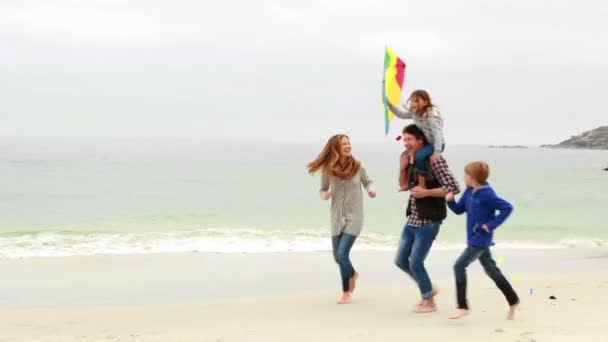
top-left (0, 228), bottom-right (608, 259)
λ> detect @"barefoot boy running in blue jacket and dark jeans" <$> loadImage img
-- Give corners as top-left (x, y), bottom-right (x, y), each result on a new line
top-left (446, 162), bottom-right (519, 320)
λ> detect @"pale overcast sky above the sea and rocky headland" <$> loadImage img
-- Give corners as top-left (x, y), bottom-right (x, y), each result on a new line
top-left (0, 0), bottom-right (608, 145)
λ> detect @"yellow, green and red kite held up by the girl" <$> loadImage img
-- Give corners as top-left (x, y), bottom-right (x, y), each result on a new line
top-left (382, 46), bottom-right (405, 134)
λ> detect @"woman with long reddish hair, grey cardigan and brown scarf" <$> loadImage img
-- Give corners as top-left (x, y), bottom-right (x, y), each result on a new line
top-left (307, 134), bottom-right (376, 304)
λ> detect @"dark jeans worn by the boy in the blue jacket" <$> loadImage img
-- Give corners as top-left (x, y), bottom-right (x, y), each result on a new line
top-left (454, 246), bottom-right (519, 310)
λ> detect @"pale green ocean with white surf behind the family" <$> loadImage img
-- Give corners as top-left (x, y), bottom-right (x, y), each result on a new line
top-left (0, 138), bottom-right (608, 258)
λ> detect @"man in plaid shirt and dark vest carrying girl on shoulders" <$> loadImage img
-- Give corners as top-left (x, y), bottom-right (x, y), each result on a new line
top-left (395, 125), bottom-right (460, 313)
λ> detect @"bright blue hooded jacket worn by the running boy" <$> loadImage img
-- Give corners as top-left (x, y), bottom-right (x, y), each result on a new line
top-left (448, 183), bottom-right (513, 247)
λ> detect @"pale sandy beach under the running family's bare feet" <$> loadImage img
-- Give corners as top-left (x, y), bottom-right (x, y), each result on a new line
top-left (0, 248), bottom-right (608, 341)
